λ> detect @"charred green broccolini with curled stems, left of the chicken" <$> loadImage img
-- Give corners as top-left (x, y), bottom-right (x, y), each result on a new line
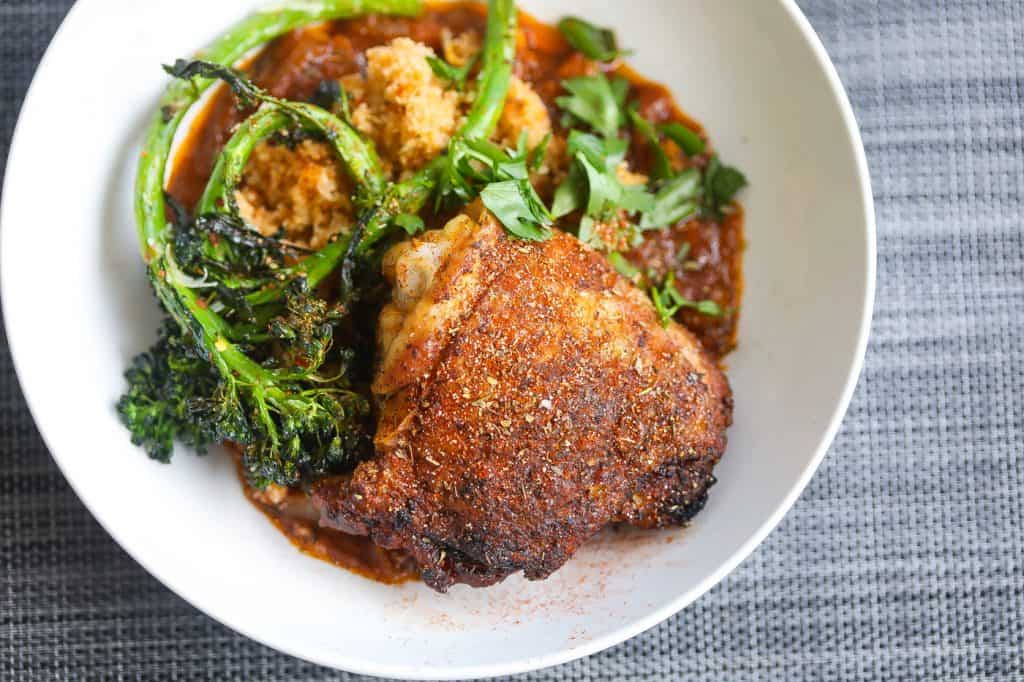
top-left (118, 0), bottom-right (516, 486)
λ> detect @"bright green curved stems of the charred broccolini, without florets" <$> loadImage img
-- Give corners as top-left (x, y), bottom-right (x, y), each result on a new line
top-left (136, 0), bottom-right (518, 352)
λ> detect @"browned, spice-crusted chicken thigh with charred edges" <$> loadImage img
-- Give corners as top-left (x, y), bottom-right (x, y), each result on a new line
top-left (312, 212), bottom-right (732, 591)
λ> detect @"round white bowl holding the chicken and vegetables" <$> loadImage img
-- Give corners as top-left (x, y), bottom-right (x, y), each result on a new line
top-left (2, 0), bottom-right (876, 678)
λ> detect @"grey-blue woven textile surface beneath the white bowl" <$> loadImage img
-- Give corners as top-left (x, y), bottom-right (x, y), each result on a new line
top-left (0, 0), bottom-right (1024, 682)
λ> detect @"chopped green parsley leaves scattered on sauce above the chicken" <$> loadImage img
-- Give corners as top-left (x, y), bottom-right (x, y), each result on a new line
top-left (552, 69), bottom-right (746, 292)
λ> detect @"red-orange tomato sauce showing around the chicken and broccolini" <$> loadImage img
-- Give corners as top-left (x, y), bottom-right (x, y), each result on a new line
top-left (168, 2), bottom-right (744, 583)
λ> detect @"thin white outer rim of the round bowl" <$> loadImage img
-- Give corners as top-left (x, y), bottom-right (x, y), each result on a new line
top-left (0, 0), bottom-right (878, 680)
